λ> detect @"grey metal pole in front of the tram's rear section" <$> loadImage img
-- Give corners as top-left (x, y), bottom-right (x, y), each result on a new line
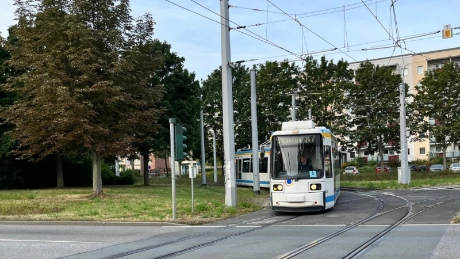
top-left (251, 69), bottom-right (260, 194)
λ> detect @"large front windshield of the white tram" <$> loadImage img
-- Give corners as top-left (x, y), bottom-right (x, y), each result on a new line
top-left (271, 134), bottom-right (324, 180)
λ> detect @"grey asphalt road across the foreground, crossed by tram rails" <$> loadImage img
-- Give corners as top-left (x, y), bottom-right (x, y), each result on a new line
top-left (0, 188), bottom-right (460, 259)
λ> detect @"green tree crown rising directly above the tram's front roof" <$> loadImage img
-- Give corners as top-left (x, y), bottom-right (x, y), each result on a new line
top-left (297, 56), bottom-right (354, 140)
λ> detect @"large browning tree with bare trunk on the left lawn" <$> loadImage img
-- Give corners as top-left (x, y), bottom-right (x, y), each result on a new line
top-left (2, 0), bottom-right (163, 195)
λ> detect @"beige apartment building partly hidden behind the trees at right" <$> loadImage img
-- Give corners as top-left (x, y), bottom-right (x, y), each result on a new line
top-left (350, 45), bottom-right (460, 161)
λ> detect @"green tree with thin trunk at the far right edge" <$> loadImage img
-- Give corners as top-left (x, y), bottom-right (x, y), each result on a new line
top-left (408, 62), bottom-right (460, 168)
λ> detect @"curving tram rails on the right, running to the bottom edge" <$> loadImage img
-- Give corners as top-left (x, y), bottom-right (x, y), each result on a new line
top-left (274, 190), bottom-right (460, 259)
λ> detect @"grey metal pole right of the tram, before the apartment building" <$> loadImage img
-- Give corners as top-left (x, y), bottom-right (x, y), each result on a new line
top-left (398, 83), bottom-right (410, 184)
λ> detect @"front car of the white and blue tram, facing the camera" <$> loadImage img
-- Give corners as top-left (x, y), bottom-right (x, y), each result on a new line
top-left (269, 120), bottom-right (342, 212)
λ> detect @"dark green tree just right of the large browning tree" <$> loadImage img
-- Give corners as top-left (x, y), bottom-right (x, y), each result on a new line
top-left (150, 40), bottom-right (201, 181)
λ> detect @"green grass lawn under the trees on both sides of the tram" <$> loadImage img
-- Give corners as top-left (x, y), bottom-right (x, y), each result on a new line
top-left (0, 169), bottom-right (460, 225)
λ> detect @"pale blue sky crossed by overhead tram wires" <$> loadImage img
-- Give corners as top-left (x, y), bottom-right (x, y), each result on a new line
top-left (0, 0), bottom-right (460, 80)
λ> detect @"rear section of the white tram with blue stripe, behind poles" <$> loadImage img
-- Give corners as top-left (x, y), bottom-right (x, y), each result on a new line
top-left (235, 144), bottom-right (270, 188)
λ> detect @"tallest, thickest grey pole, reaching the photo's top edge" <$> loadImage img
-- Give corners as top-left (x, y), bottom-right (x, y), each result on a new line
top-left (220, 0), bottom-right (236, 207)
